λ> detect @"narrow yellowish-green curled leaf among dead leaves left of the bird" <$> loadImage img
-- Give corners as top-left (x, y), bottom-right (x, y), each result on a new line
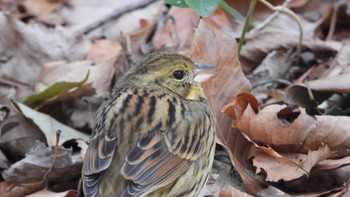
top-left (22, 72), bottom-right (89, 107)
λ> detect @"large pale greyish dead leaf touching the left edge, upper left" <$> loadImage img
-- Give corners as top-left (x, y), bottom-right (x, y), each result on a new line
top-left (0, 13), bottom-right (90, 84)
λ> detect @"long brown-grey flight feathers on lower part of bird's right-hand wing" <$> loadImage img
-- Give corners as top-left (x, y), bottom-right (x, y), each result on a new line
top-left (121, 132), bottom-right (191, 196)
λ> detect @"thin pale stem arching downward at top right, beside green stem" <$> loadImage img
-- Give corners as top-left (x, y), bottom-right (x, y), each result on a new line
top-left (259, 0), bottom-right (304, 60)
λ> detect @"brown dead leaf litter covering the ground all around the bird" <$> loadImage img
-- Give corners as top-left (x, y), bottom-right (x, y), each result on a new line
top-left (0, 0), bottom-right (350, 197)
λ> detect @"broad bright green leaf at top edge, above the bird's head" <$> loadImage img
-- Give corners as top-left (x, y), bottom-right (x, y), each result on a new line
top-left (185, 0), bottom-right (222, 17)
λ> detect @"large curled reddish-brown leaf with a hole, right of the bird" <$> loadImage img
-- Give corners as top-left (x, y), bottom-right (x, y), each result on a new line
top-left (224, 92), bottom-right (350, 157)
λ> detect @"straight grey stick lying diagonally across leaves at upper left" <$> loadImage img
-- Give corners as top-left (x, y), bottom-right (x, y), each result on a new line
top-left (74, 0), bottom-right (158, 37)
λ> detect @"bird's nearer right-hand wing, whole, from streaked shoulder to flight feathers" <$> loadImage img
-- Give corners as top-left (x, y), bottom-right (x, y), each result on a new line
top-left (121, 99), bottom-right (212, 197)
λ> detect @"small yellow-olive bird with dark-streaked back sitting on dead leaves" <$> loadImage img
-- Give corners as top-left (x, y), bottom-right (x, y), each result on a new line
top-left (80, 52), bottom-right (216, 197)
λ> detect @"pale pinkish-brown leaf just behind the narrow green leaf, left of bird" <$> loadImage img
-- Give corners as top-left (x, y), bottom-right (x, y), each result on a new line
top-left (35, 56), bottom-right (117, 100)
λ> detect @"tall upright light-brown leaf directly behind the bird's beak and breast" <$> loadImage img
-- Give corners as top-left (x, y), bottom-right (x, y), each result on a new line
top-left (188, 21), bottom-right (263, 192)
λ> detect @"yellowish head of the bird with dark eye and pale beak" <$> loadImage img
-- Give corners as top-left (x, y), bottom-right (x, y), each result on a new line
top-left (133, 53), bottom-right (215, 100)
